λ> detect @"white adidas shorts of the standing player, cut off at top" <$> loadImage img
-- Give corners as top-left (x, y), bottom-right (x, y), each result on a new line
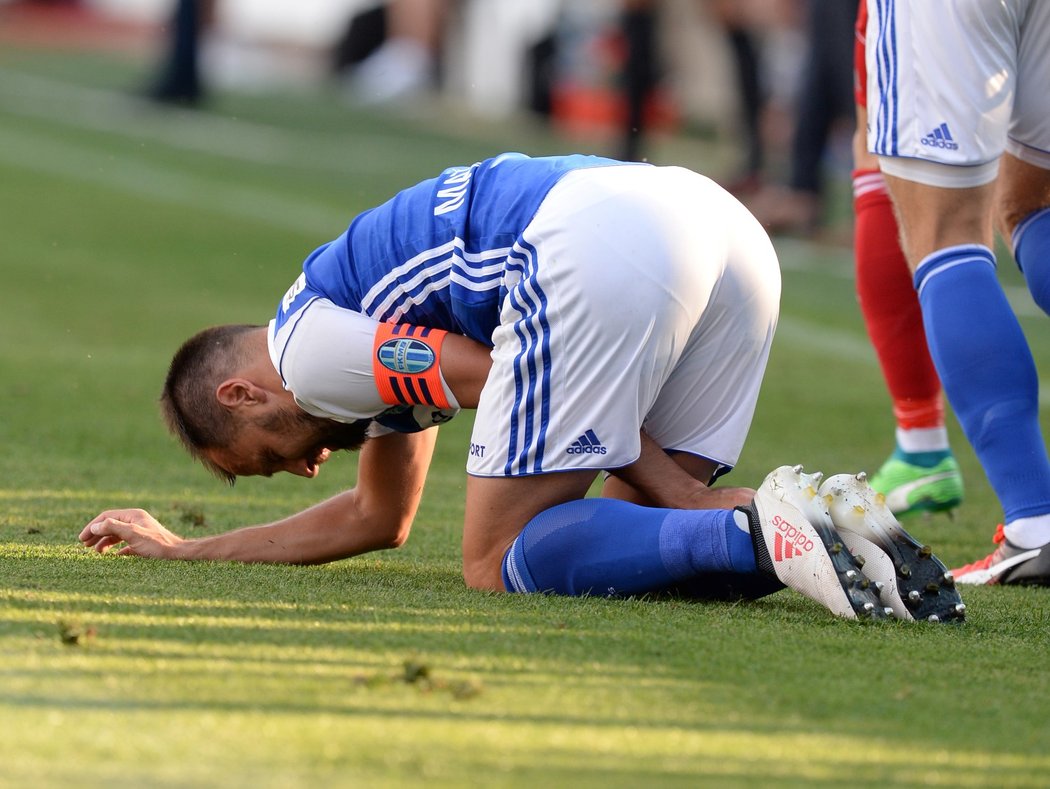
top-left (866, 0), bottom-right (1050, 187)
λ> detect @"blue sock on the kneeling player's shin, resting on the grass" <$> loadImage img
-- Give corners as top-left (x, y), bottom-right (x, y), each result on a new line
top-left (503, 498), bottom-right (758, 596)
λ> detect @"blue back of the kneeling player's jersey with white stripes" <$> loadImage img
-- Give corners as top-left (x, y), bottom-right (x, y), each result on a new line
top-left (274, 153), bottom-right (621, 344)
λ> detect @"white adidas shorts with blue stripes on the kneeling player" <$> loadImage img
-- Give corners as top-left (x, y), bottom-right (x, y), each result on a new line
top-left (467, 165), bottom-right (780, 476)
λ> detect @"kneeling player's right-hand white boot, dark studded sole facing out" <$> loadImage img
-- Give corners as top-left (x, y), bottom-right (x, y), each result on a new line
top-left (820, 473), bottom-right (966, 622)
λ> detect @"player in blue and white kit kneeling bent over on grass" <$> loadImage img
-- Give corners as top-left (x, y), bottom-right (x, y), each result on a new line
top-left (81, 154), bottom-right (962, 619)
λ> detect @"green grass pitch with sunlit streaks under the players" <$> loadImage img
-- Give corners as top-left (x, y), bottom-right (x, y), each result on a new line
top-left (0, 50), bottom-right (1050, 788)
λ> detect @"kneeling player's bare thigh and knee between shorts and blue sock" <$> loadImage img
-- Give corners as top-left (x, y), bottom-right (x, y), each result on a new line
top-left (463, 470), bottom-right (596, 590)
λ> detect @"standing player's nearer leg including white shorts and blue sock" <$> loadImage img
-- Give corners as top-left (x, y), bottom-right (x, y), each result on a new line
top-left (867, 0), bottom-right (1050, 583)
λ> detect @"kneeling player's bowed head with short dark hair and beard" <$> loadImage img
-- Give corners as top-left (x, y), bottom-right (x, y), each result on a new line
top-left (161, 325), bottom-right (368, 484)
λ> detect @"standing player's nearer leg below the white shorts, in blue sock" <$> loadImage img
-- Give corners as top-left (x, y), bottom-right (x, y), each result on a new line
top-left (887, 171), bottom-right (1050, 583)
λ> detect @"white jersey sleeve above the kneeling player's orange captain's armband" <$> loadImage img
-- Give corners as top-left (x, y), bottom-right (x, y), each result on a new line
top-left (270, 298), bottom-right (390, 422)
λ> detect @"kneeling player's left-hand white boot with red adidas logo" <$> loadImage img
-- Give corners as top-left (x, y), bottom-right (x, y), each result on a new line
top-left (738, 465), bottom-right (888, 619)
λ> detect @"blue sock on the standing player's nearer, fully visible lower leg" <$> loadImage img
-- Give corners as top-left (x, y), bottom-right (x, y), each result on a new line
top-left (915, 244), bottom-right (1050, 522)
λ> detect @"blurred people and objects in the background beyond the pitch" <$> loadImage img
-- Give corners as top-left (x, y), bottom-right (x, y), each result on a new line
top-left (0, 0), bottom-right (856, 241)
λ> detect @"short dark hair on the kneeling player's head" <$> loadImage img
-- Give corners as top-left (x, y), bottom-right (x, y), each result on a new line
top-left (161, 324), bottom-right (261, 484)
